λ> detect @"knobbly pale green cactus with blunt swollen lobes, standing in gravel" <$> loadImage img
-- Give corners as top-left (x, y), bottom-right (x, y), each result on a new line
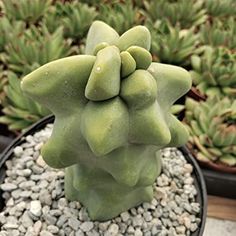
top-left (22, 21), bottom-right (191, 220)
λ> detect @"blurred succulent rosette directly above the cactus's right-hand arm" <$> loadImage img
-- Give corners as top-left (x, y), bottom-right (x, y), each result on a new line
top-left (147, 21), bottom-right (199, 66)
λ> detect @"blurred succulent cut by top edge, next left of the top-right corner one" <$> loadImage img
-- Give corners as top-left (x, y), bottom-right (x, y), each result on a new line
top-left (145, 0), bottom-right (207, 29)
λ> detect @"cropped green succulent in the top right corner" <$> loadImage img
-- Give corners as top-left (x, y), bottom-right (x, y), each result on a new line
top-left (204, 0), bottom-right (236, 17)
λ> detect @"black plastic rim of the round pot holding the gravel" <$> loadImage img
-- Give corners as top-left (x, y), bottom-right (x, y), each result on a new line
top-left (0, 116), bottom-right (207, 236)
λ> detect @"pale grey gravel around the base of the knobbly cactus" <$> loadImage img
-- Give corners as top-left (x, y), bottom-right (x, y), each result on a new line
top-left (0, 125), bottom-right (200, 236)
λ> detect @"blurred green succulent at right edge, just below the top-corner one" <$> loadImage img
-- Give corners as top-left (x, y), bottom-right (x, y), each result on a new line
top-left (200, 17), bottom-right (236, 50)
